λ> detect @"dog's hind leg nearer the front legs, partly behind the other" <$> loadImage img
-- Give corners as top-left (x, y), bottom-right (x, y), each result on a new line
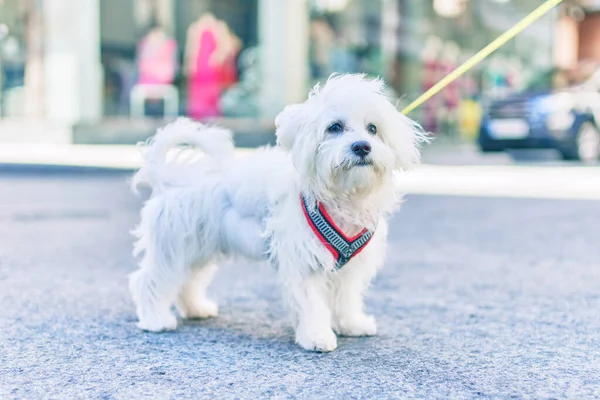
top-left (177, 263), bottom-right (219, 319)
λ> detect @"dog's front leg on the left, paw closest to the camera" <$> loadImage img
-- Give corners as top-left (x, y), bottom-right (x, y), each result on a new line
top-left (280, 272), bottom-right (337, 352)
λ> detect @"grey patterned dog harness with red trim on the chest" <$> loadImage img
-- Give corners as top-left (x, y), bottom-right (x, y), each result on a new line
top-left (300, 195), bottom-right (374, 270)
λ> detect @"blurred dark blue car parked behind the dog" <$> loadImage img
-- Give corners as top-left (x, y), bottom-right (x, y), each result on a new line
top-left (478, 62), bottom-right (600, 163)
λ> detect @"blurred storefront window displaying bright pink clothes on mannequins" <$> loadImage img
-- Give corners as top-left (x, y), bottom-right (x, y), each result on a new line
top-left (101, 0), bottom-right (258, 118)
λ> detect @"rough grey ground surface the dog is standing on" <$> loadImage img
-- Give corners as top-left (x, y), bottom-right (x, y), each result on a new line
top-left (0, 170), bottom-right (600, 399)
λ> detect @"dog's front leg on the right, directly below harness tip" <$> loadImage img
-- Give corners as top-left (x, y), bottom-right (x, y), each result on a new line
top-left (333, 258), bottom-right (377, 336)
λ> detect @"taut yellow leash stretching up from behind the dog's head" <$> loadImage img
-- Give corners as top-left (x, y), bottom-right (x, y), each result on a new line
top-left (402, 0), bottom-right (563, 114)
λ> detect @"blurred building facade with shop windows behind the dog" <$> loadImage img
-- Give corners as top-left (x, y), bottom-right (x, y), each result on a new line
top-left (0, 0), bottom-right (600, 136)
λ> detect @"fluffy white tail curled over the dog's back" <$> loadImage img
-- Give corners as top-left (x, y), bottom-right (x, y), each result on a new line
top-left (131, 118), bottom-right (234, 192)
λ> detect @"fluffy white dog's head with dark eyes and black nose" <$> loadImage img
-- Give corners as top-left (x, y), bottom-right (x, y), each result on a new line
top-left (275, 74), bottom-right (426, 198)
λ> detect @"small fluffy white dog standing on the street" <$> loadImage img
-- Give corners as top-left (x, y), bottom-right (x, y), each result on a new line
top-left (130, 75), bottom-right (427, 351)
